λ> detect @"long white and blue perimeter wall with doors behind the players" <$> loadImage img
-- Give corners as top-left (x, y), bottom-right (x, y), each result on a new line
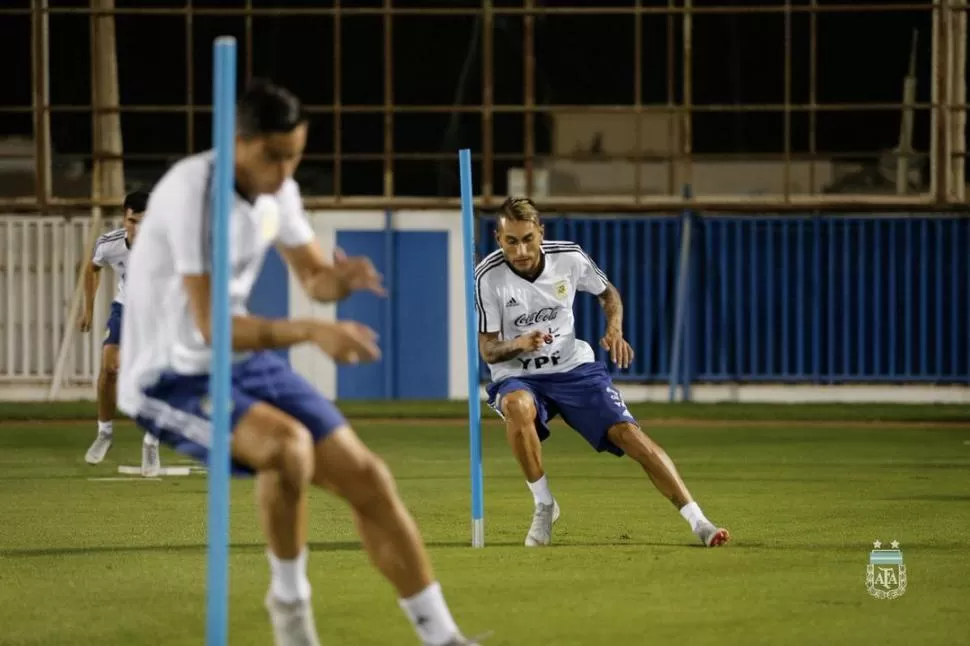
top-left (0, 211), bottom-right (970, 403)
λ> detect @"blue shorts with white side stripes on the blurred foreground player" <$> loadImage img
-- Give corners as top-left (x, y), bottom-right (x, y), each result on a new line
top-left (135, 351), bottom-right (347, 476)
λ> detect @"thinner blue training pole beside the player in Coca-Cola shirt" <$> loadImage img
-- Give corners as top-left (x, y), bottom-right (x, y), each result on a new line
top-left (458, 148), bottom-right (485, 547)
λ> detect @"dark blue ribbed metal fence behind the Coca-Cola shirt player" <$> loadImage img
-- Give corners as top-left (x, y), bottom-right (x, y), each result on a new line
top-left (478, 215), bottom-right (970, 384)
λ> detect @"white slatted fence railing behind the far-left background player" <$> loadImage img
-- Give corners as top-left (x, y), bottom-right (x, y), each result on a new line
top-left (0, 216), bottom-right (120, 387)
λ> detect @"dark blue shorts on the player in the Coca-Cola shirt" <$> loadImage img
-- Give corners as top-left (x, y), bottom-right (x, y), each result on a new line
top-left (486, 362), bottom-right (638, 456)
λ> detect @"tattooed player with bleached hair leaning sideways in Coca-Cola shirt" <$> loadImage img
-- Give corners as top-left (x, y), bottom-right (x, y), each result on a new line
top-left (475, 198), bottom-right (729, 547)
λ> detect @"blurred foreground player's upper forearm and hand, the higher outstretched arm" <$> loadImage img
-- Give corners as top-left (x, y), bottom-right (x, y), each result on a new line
top-left (279, 240), bottom-right (385, 303)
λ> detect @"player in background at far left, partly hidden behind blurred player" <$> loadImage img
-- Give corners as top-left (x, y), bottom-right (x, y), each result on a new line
top-left (78, 191), bottom-right (161, 477)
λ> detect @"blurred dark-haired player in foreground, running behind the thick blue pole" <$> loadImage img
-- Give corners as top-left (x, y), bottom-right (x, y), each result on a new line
top-left (118, 81), bottom-right (473, 646)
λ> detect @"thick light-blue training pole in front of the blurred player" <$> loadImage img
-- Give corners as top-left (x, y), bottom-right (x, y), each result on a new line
top-left (205, 36), bottom-right (236, 646)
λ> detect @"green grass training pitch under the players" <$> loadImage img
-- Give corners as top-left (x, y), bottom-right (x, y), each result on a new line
top-left (0, 405), bottom-right (970, 646)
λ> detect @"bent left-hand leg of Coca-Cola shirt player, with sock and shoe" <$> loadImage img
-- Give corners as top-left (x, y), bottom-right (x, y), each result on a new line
top-left (497, 390), bottom-right (559, 547)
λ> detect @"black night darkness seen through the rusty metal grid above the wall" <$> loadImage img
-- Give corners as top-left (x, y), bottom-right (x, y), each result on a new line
top-left (0, 0), bottom-right (952, 195)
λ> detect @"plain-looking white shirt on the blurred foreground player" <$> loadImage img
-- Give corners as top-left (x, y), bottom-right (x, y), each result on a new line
top-left (118, 151), bottom-right (314, 416)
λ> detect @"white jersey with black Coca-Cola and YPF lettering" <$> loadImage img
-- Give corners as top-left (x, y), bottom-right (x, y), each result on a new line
top-left (475, 240), bottom-right (609, 381)
